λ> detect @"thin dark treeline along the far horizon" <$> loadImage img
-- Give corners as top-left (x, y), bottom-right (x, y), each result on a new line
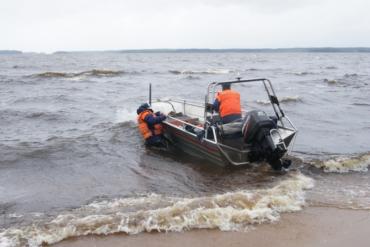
top-left (55, 47), bottom-right (370, 54)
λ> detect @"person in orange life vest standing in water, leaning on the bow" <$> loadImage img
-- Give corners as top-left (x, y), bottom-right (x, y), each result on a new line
top-left (136, 103), bottom-right (166, 147)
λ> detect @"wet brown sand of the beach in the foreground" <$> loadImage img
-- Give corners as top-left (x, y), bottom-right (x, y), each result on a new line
top-left (54, 207), bottom-right (370, 247)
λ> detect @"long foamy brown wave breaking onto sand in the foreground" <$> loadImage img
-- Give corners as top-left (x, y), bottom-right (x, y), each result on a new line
top-left (0, 173), bottom-right (314, 246)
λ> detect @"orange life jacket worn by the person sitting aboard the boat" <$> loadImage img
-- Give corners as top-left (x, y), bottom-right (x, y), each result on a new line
top-left (216, 89), bottom-right (242, 117)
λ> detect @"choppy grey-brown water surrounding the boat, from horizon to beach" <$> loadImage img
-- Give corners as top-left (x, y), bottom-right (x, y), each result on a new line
top-left (0, 53), bottom-right (370, 246)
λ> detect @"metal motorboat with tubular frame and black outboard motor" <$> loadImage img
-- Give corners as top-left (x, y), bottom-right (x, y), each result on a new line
top-left (150, 78), bottom-right (297, 170)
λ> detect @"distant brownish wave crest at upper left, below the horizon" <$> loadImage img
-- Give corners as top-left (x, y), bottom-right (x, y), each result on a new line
top-left (31, 69), bottom-right (125, 78)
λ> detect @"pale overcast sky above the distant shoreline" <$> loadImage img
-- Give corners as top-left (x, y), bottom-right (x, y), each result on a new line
top-left (0, 0), bottom-right (370, 52)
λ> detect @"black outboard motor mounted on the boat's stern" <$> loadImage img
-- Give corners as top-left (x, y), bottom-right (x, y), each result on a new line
top-left (242, 110), bottom-right (290, 170)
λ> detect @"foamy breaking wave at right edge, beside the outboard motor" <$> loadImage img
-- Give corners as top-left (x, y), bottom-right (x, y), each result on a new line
top-left (309, 153), bottom-right (370, 173)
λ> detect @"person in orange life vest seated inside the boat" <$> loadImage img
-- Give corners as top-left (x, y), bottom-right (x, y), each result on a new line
top-left (212, 83), bottom-right (242, 124)
